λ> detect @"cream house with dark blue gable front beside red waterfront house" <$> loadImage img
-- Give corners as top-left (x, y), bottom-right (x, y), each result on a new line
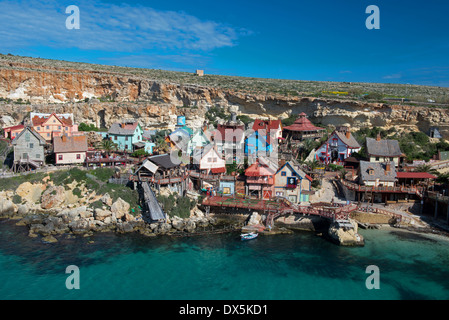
top-left (274, 162), bottom-right (313, 203)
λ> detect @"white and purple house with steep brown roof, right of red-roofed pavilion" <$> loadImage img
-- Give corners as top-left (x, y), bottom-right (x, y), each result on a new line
top-left (315, 128), bottom-right (362, 165)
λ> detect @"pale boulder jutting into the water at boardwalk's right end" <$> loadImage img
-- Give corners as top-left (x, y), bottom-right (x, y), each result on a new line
top-left (328, 219), bottom-right (364, 246)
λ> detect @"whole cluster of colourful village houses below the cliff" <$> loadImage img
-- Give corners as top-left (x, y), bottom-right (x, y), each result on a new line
top-left (3, 113), bottom-right (446, 228)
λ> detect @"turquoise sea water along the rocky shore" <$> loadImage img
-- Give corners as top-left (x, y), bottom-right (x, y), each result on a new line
top-left (0, 221), bottom-right (449, 300)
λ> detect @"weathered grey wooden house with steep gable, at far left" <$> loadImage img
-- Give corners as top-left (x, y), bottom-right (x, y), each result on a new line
top-left (12, 127), bottom-right (47, 172)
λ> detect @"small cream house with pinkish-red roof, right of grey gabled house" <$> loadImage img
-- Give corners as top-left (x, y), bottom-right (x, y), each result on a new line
top-left (53, 135), bottom-right (88, 165)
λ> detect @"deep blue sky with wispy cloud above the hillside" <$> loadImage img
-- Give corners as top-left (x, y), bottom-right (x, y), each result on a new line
top-left (0, 0), bottom-right (449, 87)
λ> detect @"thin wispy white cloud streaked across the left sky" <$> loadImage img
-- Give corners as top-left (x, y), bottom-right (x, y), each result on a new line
top-left (0, 0), bottom-right (245, 52)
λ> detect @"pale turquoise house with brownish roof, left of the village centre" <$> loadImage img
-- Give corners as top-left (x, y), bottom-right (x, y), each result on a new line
top-left (107, 122), bottom-right (143, 152)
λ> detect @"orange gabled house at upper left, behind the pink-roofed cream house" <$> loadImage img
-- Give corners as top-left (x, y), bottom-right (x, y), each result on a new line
top-left (31, 113), bottom-right (78, 141)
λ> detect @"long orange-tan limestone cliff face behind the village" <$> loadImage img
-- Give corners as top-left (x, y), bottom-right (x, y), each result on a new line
top-left (0, 62), bottom-right (449, 139)
